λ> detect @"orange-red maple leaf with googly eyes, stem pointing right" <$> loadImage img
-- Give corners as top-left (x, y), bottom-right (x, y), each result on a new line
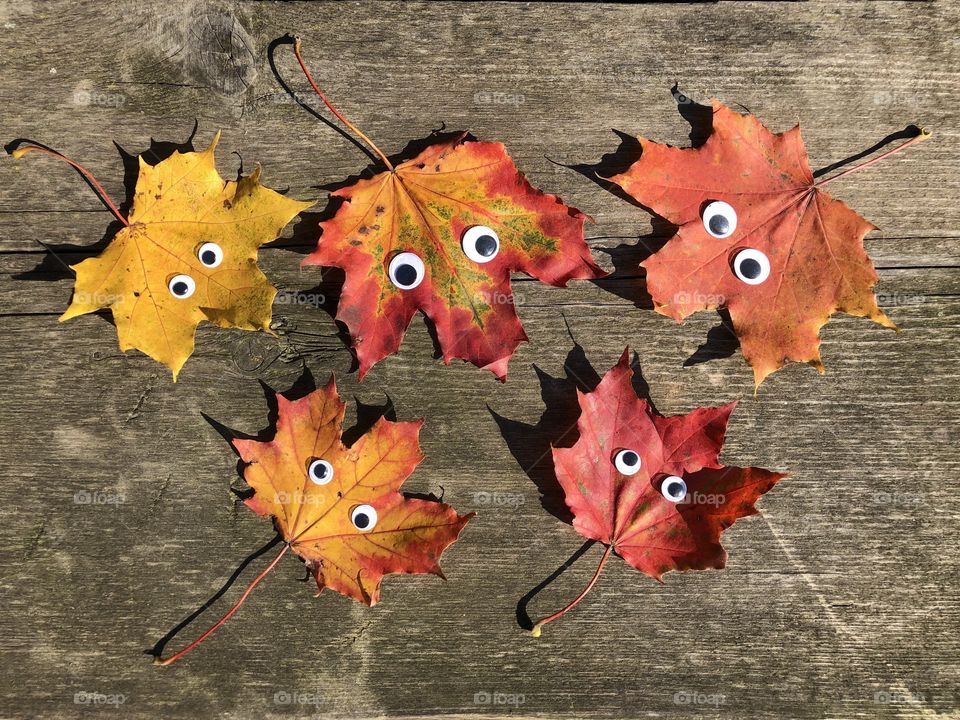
top-left (611, 101), bottom-right (927, 386)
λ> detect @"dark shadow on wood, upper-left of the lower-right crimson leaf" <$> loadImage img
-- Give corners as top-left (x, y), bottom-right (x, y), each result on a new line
top-left (487, 341), bottom-right (655, 524)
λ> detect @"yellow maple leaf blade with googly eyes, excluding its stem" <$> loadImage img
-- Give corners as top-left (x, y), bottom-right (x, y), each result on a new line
top-left (27, 132), bottom-right (313, 380)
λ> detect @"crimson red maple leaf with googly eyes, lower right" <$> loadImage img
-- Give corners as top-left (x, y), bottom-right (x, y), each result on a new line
top-left (533, 349), bottom-right (786, 635)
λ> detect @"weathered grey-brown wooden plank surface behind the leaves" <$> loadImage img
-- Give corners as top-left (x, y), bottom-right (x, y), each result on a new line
top-left (0, 0), bottom-right (960, 718)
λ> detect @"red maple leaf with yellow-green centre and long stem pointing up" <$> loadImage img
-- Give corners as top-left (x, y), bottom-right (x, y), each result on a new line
top-left (296, 38), bottom-right (605, 380)
